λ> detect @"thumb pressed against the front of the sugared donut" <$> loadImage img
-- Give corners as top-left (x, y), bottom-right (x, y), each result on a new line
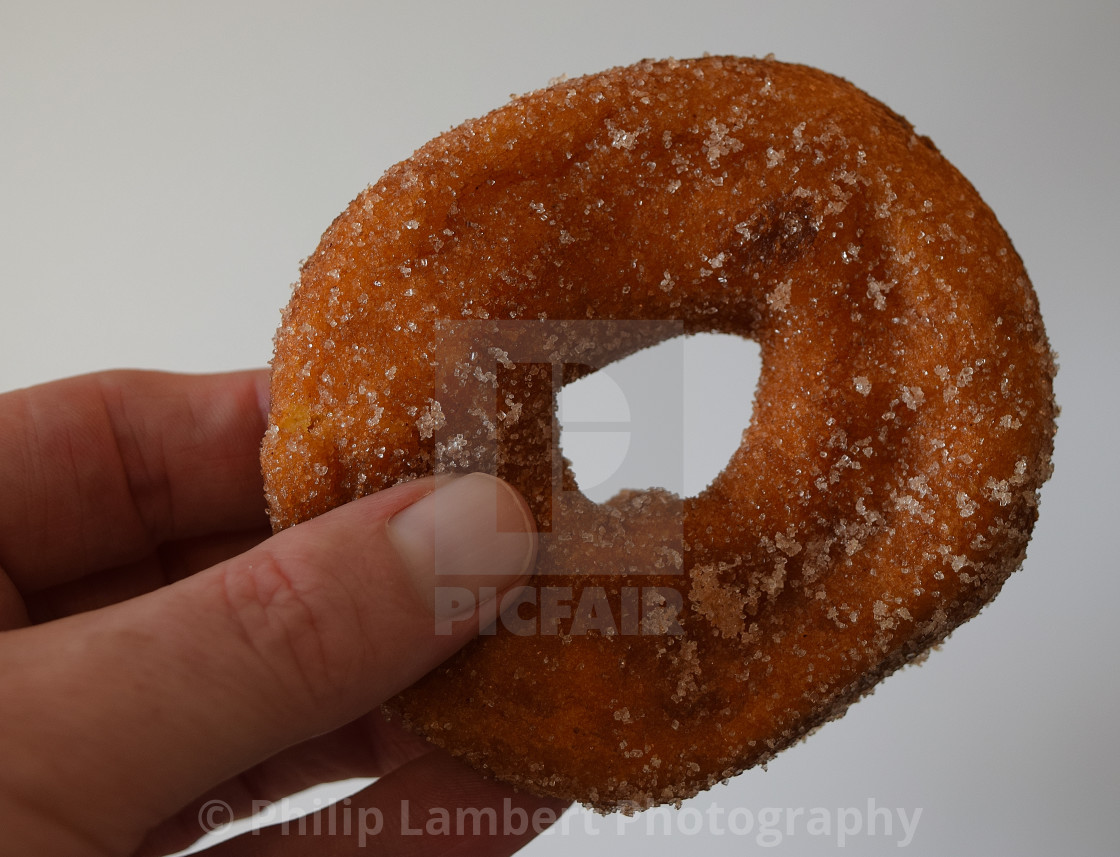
top-left (0, 474), bottom-right (536, 853)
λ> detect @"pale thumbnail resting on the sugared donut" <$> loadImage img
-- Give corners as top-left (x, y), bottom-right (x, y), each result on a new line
top-left (385, 473), bottom-right (536, 620)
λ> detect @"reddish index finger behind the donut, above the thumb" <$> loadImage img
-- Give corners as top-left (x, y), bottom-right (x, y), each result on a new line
top-left (0, 370), bottom-right (268, 591)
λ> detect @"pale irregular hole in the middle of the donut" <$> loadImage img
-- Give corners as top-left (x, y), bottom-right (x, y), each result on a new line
top-left (557, 334), bottom-right (762, 503)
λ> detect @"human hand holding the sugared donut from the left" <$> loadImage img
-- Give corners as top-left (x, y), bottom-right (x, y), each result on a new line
top-left (0, 372), bottom-right (563, 857)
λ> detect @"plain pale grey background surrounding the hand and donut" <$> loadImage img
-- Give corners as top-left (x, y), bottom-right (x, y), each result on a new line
top-left (0, 0), bottom-right (1120, 857)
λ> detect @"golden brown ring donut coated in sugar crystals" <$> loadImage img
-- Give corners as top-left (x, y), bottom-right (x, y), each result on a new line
top-left (263, 57), bottom-right (1055, 810)
